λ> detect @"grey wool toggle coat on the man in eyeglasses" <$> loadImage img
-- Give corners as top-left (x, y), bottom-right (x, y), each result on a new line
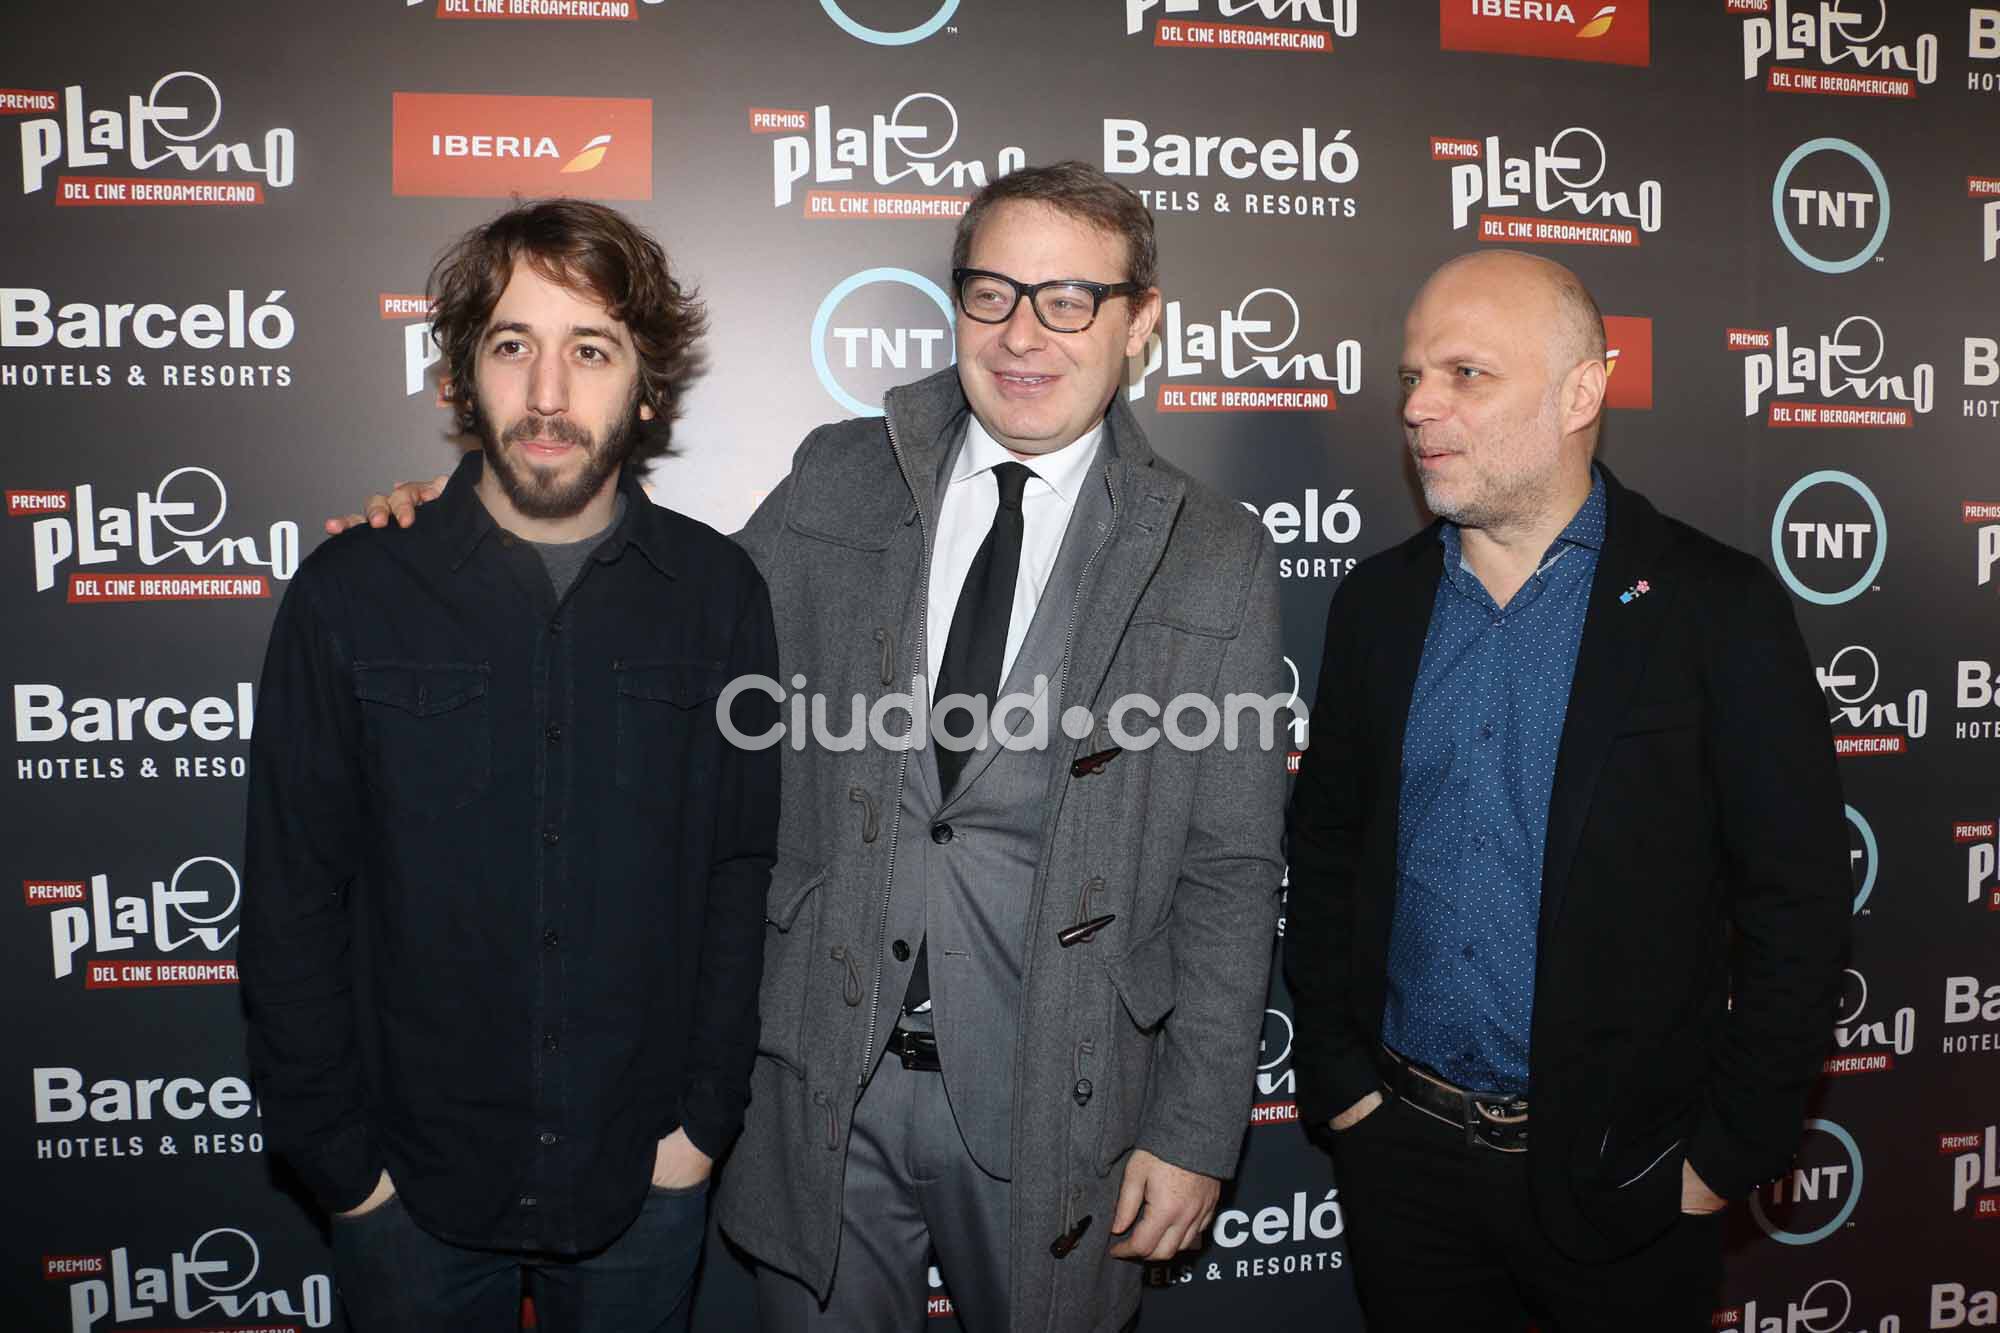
top-left (718, 368), bottom-right (1284, 1333)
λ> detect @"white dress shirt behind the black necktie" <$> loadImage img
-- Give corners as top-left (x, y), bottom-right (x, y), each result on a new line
top-left (924, 416), bottom-right (1104, 683)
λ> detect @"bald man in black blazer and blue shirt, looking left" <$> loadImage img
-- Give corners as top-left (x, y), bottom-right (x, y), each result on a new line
top-left (1286, 250), bottom-right (1852, 1333)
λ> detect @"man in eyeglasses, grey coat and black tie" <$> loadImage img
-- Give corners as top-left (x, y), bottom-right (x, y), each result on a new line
top-left (330, 162), bottom-right (1284, 1333)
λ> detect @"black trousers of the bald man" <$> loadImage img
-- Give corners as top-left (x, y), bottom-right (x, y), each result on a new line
top-left (1334, 1097), bottom-right (1722, 1333)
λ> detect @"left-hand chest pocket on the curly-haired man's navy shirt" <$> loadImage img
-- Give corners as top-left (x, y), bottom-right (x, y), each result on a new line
top-left (354, 662), bottom-right (492, 815)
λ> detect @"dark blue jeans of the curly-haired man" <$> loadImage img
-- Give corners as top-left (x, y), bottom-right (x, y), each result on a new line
top-left (334, 1185), bottom-right (708, 1333)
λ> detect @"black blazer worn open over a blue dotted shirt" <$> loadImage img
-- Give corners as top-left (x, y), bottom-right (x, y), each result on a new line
top-left (1286, 468), bottom-right (1852, 1259)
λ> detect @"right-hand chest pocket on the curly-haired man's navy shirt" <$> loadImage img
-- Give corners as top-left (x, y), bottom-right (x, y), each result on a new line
top-left (612, 658), bottom-right (724, 805)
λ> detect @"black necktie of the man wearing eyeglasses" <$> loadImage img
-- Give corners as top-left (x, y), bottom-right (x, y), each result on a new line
top-left (902, 462), bottom-right (1034, 1009)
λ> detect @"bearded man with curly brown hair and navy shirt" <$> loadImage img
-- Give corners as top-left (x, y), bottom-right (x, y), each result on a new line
top-left (240, 200), bottom-right (778, 1333)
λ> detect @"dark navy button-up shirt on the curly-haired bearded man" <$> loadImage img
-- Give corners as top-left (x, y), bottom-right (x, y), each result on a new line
top-left (238, 452), bottom-right (778, 1255)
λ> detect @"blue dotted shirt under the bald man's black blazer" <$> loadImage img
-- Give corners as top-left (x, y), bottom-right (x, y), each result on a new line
top-left (1382, 466), bottom-right (1604, 1093)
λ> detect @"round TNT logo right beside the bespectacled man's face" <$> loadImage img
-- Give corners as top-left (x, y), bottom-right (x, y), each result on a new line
top-left (812, 268), bottom-right (956, 416)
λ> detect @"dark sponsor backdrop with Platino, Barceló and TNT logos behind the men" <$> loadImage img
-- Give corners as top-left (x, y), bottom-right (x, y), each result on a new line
top-left (0, 0), bottom-right (2000, 1333)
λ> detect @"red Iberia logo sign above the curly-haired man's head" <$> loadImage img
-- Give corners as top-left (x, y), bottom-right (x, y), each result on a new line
top-left (392, 92), bottom-right (652, 200)
